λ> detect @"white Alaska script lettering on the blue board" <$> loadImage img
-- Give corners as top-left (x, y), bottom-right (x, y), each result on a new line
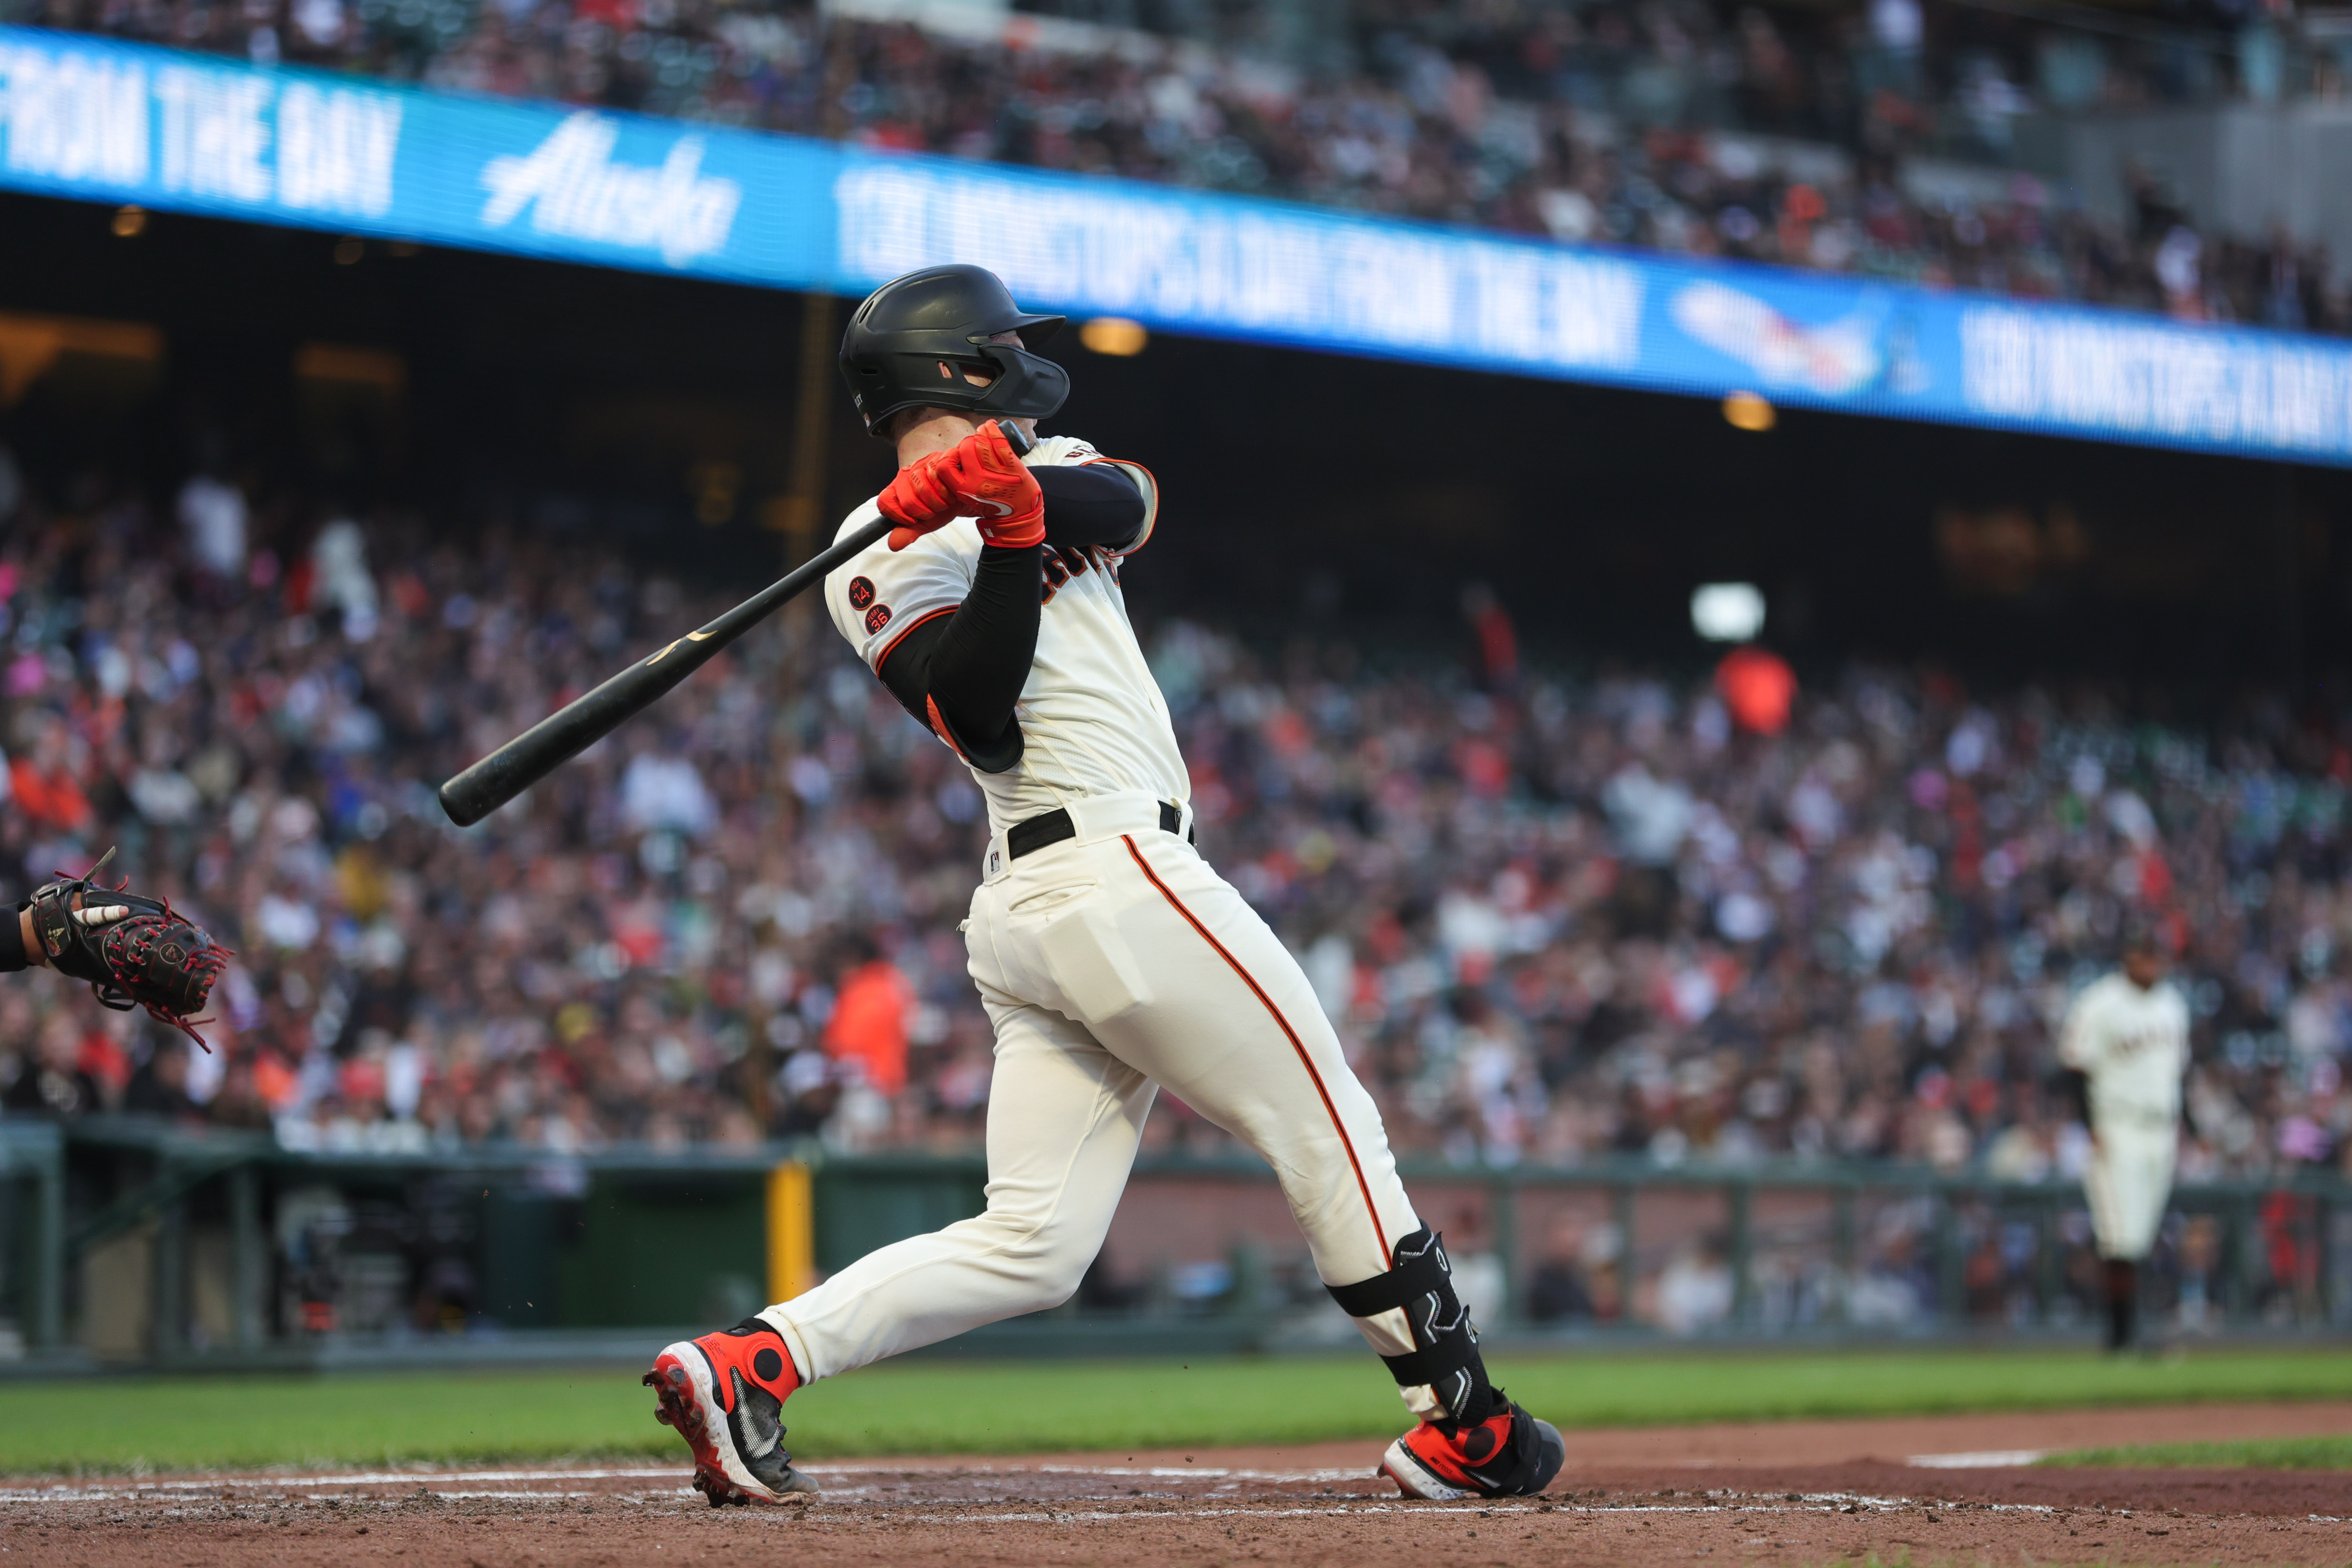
top-left (482, 113), bottom-right (743, 265)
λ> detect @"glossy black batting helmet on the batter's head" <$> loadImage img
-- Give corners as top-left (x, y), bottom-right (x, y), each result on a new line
top-left (842, 265), bottom-right (1070, 435)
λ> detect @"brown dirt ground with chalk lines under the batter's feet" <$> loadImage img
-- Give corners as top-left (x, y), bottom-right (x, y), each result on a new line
top-left (0, 1404), bottom-right (2352, 1568)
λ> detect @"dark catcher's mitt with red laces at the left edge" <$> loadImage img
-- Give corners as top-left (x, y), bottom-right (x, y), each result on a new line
top-left (30, 849), bottom-right (228, 1051)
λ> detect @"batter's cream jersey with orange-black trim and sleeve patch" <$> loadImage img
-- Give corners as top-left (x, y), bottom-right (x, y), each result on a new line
top-left (826, 435), bottom-right (1193, 832)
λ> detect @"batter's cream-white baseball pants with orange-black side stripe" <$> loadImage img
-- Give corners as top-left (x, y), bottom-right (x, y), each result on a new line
top-left (760, 792), bottom-right (1437, 1413)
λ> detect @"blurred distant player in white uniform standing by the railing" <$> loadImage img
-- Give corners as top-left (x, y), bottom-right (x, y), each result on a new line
top-left (2058, 929), bottom-right (2190, 1349)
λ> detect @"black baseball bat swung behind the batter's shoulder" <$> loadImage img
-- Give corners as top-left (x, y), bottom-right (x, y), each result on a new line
top-left (440, 418), bottom-right (1035, 828)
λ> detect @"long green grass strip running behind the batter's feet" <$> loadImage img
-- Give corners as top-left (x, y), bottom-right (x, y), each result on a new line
top-left (14, 1352), bottom-right (2352, 1474)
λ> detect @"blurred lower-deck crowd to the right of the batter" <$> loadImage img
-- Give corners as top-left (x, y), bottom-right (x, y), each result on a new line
top-left (1159, 625), bottom-right (2352, 1178)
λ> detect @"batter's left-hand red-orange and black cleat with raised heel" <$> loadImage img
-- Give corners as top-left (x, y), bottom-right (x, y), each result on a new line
top-left (645, 1316), bottom-right (816, 1507)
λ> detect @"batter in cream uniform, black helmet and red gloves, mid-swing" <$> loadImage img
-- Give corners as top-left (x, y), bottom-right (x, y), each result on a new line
top-left (647, 265), bottom-right (1564, 1505)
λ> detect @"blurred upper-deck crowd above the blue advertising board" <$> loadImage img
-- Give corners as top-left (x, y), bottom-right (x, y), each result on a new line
top-left (23, 0), bottom-right (2352, 332)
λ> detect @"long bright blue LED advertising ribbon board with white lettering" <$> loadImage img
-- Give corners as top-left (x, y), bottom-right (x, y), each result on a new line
top-left (0, 28), bottom-right (2352, 466)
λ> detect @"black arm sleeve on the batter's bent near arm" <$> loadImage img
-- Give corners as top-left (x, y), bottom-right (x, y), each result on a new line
top-left (877, 546), bottom-right (1044, 773)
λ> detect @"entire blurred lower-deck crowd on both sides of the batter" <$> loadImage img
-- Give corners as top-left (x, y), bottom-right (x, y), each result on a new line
top-left (0, 461), bottom-right (2352, 1180)
